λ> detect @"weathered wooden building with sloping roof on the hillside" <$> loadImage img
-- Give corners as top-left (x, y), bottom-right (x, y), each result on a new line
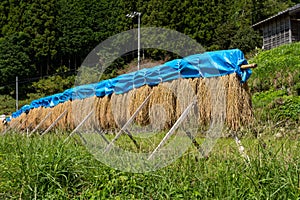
top-left (252, 4), bottom-right (300, 49)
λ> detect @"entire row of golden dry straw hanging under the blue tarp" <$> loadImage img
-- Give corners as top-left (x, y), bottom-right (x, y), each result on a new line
top-left (9, 74), bottom-right (253, 133)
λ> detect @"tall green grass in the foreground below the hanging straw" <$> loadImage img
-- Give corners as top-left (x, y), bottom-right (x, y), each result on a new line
top-left (0, 133), bottom-right (300, 199)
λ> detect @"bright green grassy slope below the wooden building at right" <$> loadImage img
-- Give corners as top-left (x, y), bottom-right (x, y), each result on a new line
top-left (249, 43), bottom-right (300, 122)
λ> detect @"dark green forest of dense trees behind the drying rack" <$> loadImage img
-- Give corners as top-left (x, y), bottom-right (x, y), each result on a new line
top-left (0, 0), bottom-right (299, 99)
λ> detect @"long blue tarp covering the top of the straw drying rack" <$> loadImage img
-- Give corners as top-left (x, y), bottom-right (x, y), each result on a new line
top-left (8, 49), bottom-right (252, 118)
